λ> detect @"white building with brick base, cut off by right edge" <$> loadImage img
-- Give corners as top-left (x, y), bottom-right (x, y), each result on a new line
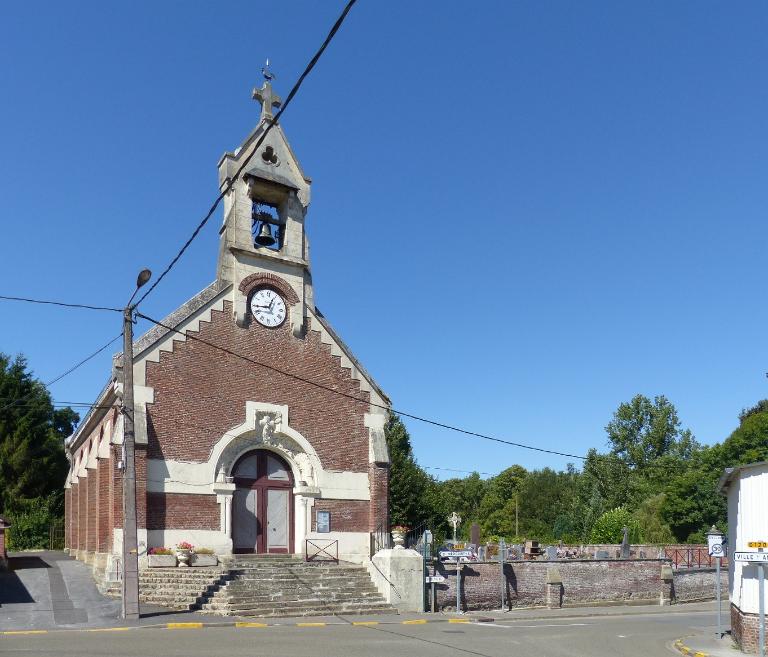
top-left (720, 461), bottom-right (768, 652)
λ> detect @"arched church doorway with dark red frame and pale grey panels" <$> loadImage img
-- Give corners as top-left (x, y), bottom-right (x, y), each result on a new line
top-left (232, 449), bottom-right (293, 553)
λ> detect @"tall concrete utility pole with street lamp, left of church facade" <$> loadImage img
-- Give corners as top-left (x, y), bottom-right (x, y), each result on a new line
top-left (122, 269), bottom-right (152, 620)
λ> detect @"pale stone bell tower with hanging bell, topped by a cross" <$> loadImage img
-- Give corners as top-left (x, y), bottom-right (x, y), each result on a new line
top-left (216, 69), bottom-right (314, 337)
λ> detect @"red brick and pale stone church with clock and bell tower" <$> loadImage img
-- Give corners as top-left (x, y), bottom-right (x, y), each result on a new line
top-left (65, 74), bottom-right (389, 573)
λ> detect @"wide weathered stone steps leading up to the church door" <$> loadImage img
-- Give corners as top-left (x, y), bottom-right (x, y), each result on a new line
top-left (139, 555), bottom-right (397, 617)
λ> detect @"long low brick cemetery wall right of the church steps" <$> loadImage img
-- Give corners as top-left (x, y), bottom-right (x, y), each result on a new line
top-left (437, 559), bottom-right (673, 609)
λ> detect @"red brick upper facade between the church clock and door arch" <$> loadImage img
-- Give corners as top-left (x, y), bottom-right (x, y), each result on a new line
top-left (146, 302), bottom-right (369, 474)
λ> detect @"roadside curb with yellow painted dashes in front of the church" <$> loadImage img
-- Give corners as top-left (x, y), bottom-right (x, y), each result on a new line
top-left (0, 618), bottom-right (492, 632)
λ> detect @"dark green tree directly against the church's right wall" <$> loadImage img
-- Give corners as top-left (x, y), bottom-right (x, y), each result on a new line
top-left (384, 413), bottom-right (433, 527)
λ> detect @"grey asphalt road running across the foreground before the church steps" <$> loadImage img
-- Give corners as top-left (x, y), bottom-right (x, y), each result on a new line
top-left (0, 610), bottom-right (714, 657)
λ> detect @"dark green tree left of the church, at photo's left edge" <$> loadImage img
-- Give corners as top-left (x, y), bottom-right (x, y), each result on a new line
top-left (0, 354), bottom-right (80, 516)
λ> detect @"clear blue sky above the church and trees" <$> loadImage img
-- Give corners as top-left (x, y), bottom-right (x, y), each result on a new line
top-left (0, 0), bottom-right (768, 476)
